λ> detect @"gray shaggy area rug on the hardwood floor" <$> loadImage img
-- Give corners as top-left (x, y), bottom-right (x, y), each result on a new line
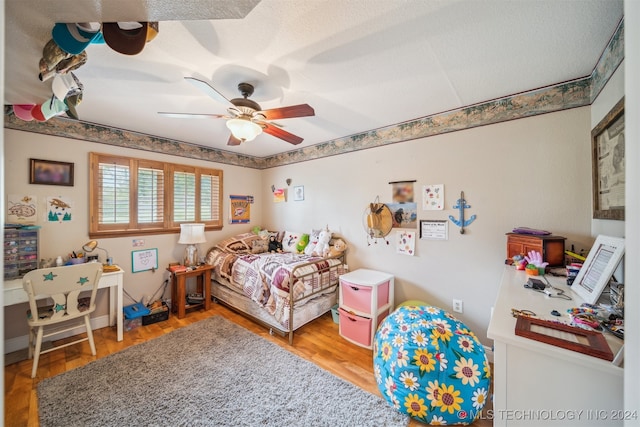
top-left (37, 316), bottom-right (408, 427)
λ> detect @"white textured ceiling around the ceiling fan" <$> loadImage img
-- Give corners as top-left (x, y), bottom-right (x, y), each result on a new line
top-left (4, 0), bottom-right (623, 157)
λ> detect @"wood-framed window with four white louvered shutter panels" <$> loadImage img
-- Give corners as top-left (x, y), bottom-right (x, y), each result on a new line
top-left (89, 153), bottom-right (222, 237)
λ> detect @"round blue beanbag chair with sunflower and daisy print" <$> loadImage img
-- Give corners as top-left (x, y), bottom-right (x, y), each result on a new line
top-left (373, 305), bottom-right (491, 425)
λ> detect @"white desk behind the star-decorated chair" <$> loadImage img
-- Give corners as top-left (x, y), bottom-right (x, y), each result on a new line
top-left (4, 269), bottom-right (124, 341)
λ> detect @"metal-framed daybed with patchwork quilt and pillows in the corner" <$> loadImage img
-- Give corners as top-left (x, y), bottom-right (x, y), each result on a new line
top-left (205, 233), bottom-right (348, 344)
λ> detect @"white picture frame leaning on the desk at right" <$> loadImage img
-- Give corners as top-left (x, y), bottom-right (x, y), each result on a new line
top-left (571, 235), bottom-right (624, 304)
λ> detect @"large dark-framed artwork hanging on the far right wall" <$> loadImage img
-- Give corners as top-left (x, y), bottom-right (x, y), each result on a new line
top-left (591, 98), bottom-right (625, 220)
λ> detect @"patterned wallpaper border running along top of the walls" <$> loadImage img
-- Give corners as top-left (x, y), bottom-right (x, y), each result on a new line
top-left (4, 21), bottom-right (624, 169)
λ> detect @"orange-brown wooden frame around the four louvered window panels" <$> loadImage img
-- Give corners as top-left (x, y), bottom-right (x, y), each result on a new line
top-left (89, 153), bottom-right (224, 238)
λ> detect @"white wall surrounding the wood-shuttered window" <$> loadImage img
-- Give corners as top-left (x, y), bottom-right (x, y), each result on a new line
top-left (4, 129), bottom-right (262, 339)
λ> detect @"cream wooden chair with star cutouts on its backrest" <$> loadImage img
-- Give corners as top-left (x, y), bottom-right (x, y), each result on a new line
top-left (22, 262), bottom-right (102, 378)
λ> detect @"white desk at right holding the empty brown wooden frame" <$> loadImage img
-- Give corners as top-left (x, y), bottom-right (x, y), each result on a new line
top-left (487, 266), bottom-right (624, 427)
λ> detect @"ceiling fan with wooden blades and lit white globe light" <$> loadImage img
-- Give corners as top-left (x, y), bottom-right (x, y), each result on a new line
top-left (158, 77), bottom-right (315, 145)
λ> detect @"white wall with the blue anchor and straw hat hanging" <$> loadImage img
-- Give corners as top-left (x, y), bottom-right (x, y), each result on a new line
top-left (262, 107), bottom-right (593, 345)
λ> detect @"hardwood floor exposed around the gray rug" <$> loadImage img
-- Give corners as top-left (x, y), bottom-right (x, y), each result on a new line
top-left (4, 304), bottom-right (492, 427)
